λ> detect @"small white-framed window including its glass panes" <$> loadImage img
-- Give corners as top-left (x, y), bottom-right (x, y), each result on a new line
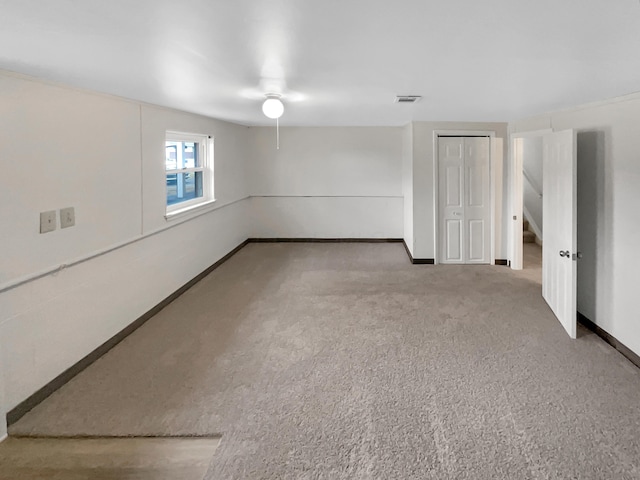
top-left (165, 132), bottom-right (214, 215)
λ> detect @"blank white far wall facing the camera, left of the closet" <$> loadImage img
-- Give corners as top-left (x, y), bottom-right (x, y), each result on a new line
top-left (249, 127), bottom-right (403, 238)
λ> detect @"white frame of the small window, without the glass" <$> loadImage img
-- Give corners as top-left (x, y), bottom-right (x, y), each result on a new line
top-left (164, 131), bottom-right (215, 219)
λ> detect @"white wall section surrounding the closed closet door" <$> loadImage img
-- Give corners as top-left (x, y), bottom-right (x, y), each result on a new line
top-left (413, 122), bottom-right (508, 259)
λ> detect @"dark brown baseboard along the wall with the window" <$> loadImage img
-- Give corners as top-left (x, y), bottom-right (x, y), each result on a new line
top-left (7, 240), bottom-right (249, 426)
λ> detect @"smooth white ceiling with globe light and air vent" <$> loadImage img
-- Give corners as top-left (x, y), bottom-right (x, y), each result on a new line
top-left (0, 0), bottom-right (640, 126)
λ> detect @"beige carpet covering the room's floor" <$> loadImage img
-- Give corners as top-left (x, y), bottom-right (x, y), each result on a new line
top-left (11, 244), bottom-right (640, 480)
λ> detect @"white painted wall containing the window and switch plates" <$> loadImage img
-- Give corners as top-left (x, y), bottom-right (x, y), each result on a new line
top-left (0, 73), bottom-right (249, 424)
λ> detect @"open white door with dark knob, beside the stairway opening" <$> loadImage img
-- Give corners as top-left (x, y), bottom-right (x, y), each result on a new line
top-left (542, 130), bottom-right (578, 338)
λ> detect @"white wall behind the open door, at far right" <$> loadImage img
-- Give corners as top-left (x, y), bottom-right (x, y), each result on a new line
top-left (510, 95), bottom-right (640, 354)
